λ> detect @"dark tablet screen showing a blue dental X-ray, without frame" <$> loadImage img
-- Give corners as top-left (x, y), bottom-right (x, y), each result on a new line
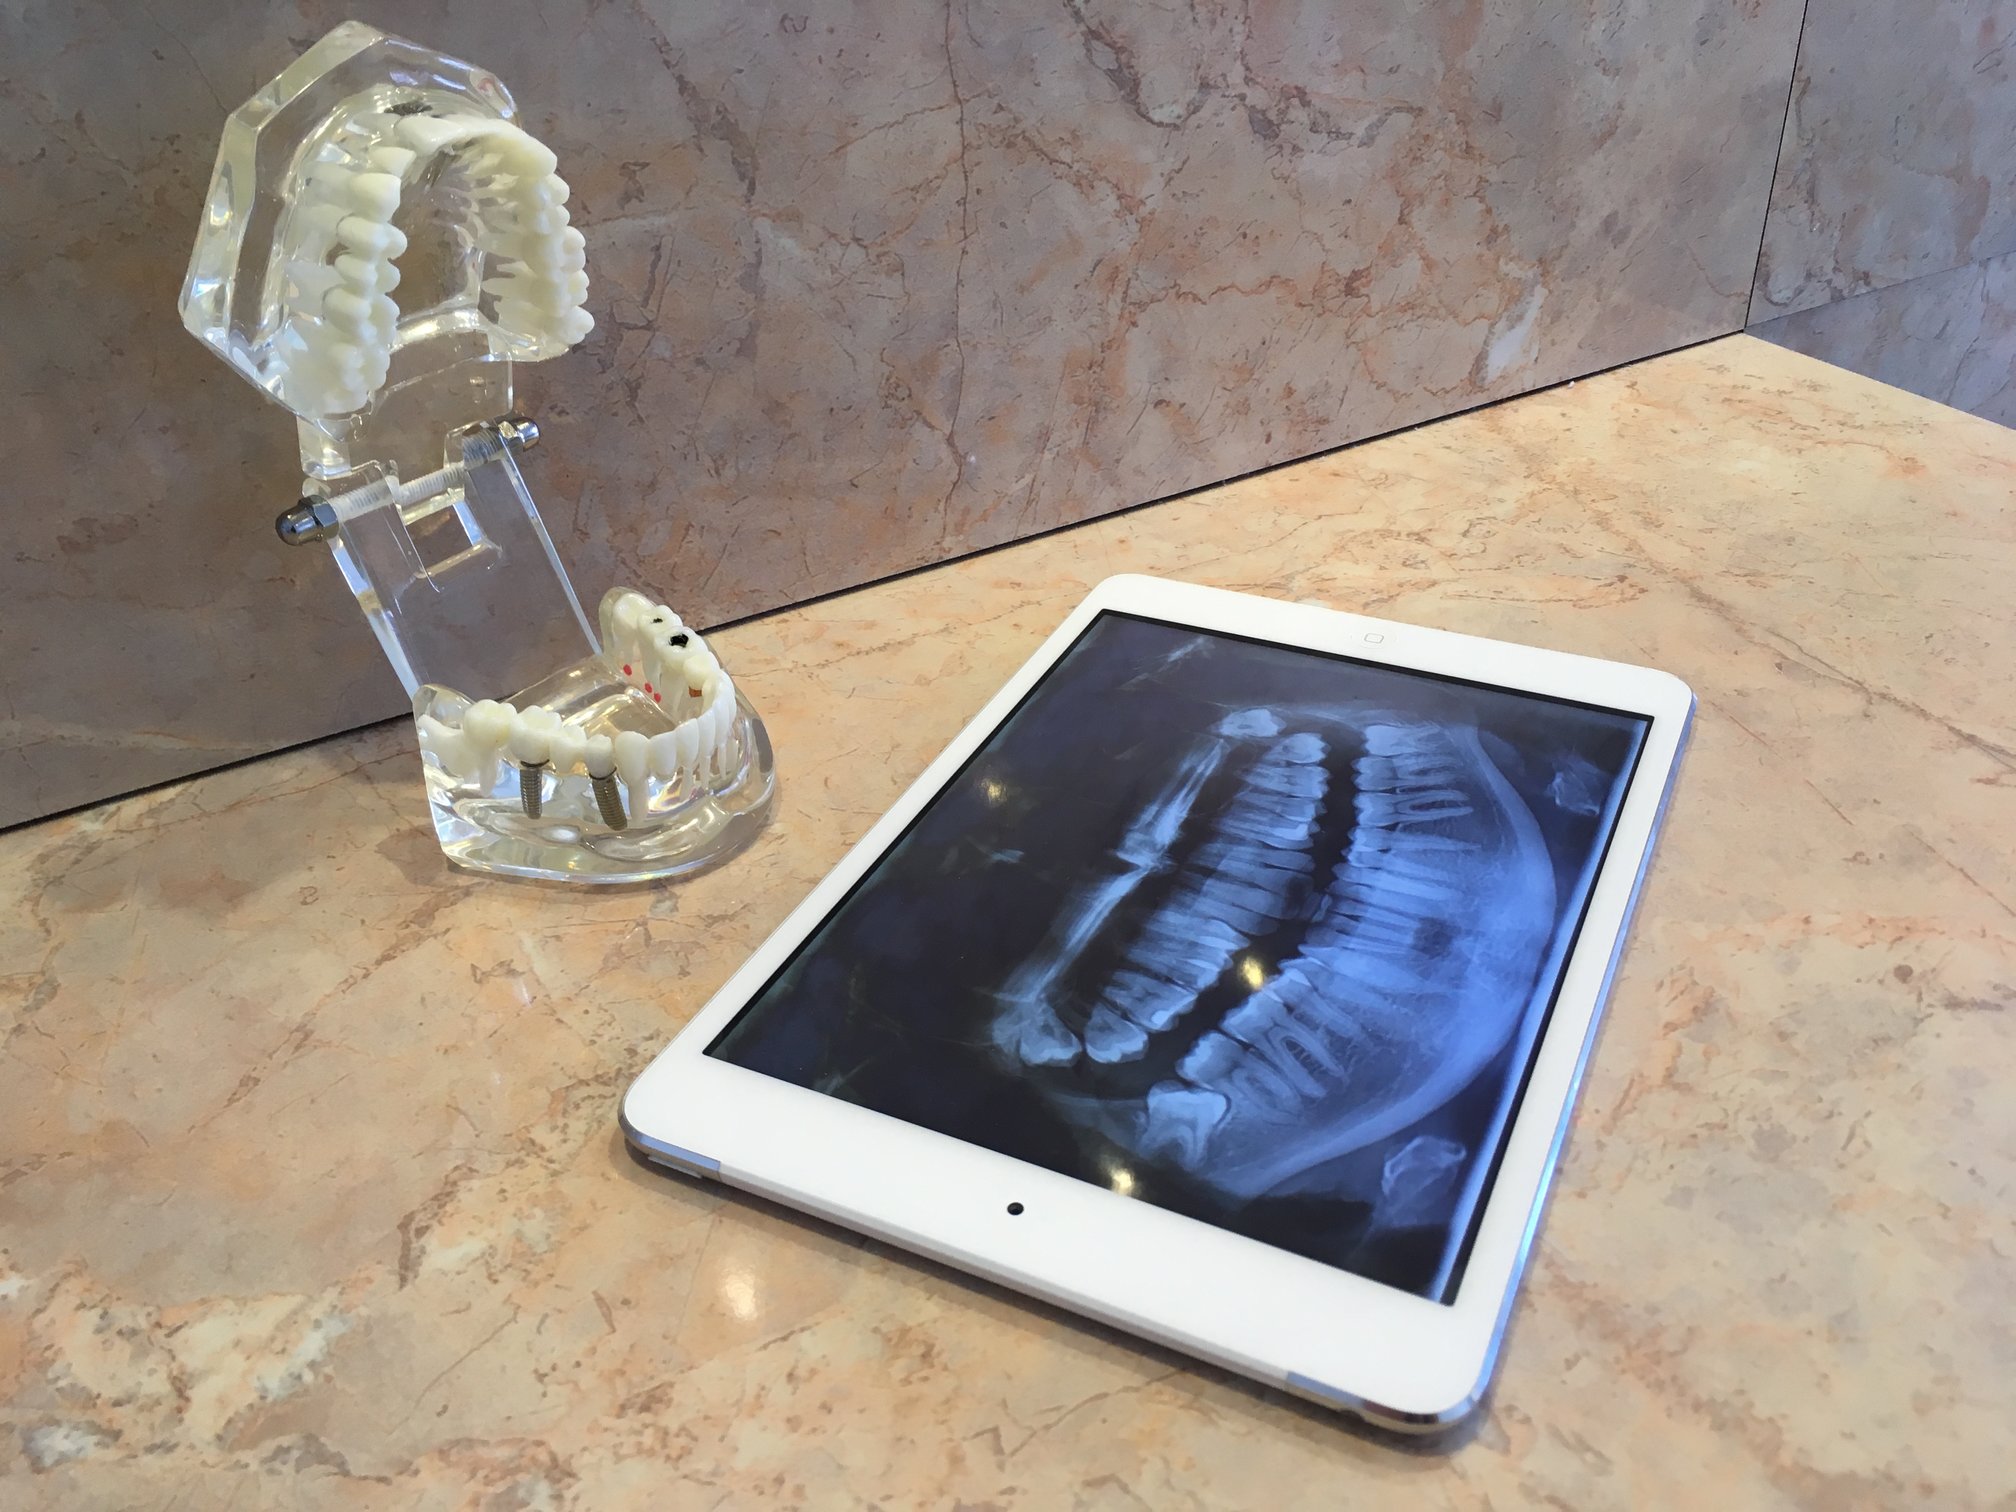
top-left (708, 611), bottom-right (1651, 1302)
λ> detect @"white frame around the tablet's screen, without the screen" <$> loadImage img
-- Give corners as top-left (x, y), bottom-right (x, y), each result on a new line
top-left (623, 577), bottom-right (1693, 1429)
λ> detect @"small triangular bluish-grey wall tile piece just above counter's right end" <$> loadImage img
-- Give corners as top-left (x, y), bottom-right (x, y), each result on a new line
top-left (1750, 254), bottom-right (2016, 425)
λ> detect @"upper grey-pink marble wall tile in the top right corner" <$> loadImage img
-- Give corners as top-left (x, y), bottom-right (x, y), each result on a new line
top-left (1750, 0), bottom-right (2016, 323)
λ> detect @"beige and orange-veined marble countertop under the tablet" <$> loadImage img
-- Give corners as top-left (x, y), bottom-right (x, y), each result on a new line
top-left (0, 337), bottom-right (2016, 1508)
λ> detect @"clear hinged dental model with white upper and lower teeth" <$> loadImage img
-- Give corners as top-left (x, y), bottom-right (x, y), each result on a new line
top-left (181, 22), bottom-right (776, 883)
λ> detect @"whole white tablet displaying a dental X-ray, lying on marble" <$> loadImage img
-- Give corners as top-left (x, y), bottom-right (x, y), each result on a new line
top-left (623, 577), bottom-right (1693, 1431)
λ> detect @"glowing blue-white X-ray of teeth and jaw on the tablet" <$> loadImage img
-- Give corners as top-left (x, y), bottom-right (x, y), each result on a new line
top-left (992, 710), bottom-right (1554, 1202)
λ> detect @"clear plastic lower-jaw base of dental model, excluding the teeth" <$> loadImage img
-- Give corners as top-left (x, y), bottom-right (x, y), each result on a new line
top-left (413, 657), bottom-right (776, 883)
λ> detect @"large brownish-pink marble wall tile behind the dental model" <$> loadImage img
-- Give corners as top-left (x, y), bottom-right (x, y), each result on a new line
top-left (0, 0), bottom-right (1798, 823)
